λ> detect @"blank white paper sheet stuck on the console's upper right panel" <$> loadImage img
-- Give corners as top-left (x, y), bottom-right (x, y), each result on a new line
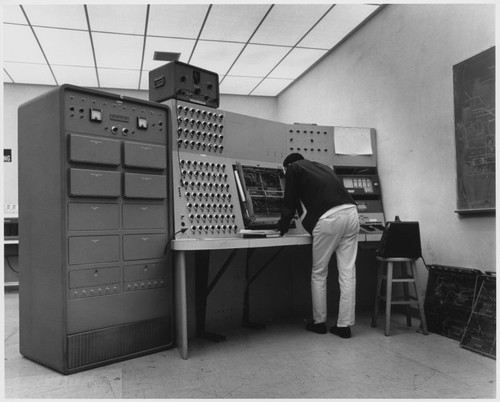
top-left (333, 127), bottom-right (373, 155)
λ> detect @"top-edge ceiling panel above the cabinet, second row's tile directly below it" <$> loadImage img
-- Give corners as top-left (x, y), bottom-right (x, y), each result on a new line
top-left (87, 4), bottom-right (147, 35)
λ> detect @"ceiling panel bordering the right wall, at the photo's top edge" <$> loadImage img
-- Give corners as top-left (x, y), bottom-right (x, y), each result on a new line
top-left (298, 4), bottom-right (378, 49)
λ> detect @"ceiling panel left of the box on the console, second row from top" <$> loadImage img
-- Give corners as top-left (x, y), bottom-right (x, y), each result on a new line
top-left (92, 33), bottom-right (144, 70)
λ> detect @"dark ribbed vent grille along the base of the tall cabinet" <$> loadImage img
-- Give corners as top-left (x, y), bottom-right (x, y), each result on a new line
top-left (67, 317), bottom-right (172, 370)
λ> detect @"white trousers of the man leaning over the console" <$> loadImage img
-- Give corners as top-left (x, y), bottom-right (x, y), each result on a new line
top-left (311, 206), bottom-right (359, 326)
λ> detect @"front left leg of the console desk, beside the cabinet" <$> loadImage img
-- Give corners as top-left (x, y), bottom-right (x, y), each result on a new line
top-left (175, 251), bottom-right (188, 359)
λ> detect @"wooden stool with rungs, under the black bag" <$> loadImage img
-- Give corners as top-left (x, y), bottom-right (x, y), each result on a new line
top-left (372, 257), bottom-right (428, 336)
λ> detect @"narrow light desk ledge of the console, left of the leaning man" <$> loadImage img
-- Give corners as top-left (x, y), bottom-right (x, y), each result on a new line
top-left (171, 235), bottom-right (312, 251)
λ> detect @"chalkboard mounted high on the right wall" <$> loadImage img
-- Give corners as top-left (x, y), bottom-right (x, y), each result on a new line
top-left (453, 47), bottom-right (495, 213)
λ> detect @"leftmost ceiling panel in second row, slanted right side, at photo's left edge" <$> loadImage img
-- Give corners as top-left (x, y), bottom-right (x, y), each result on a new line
top-left (3, 24), bottom-right (46, 64)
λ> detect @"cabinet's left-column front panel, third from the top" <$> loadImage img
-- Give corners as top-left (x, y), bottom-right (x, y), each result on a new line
top-left (68, 203), bottom-right (120, 230)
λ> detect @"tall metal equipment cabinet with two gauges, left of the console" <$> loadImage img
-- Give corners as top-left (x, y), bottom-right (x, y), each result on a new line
top-left (18, 85), bottom-right (173, 374)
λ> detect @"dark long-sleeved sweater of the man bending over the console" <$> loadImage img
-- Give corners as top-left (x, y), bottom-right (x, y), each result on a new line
top-left (279, 160), bottom-right (356, 234)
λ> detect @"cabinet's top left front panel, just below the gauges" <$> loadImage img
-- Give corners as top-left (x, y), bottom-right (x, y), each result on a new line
top-left (68, 134), bottom-right (120, 166)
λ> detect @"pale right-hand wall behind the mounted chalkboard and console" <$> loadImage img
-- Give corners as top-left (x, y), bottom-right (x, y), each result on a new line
top-left (278, 4), bottom-right (496, 270)
